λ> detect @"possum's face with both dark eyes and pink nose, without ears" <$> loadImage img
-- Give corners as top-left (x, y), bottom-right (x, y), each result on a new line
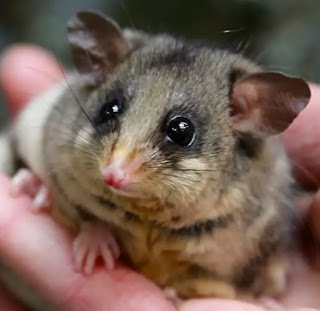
top-left (83, 46), bottom-right (238, 205)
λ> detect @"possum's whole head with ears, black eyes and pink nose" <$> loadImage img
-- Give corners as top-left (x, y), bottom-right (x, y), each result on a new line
top-left (67, 13), bottom-right (309, 210)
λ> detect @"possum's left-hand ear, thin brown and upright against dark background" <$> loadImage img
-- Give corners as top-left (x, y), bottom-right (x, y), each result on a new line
top-left (68, 11), bottom-right (128, 81)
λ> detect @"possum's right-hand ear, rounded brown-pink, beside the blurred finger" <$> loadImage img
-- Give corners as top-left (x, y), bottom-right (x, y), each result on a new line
top-left (231, 72), bottom-right (311, 136)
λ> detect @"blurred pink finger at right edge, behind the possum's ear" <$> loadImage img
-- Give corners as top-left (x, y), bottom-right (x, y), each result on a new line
top-left (282, 85), bottom-right (320, 188)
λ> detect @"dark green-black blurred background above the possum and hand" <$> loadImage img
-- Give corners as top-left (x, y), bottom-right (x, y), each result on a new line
top-left (0, 0), bottom-right (320, 124)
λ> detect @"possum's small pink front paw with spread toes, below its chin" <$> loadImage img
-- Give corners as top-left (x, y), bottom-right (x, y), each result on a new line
top-left (73, 222), bottom-right (120, 275)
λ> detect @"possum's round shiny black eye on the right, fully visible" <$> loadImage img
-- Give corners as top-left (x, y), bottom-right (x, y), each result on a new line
top-left (166, 117), bottom-right (195, 147)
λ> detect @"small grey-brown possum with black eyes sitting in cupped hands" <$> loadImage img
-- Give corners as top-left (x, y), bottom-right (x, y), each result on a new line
top-left (0, 12), bottom-right (310, 310)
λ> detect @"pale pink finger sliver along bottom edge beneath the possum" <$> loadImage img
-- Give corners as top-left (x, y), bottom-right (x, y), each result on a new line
top-left (179, 299), bottom-right (264, 311)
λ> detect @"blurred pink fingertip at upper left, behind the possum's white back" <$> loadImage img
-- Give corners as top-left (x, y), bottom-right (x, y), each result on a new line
top-left (0, 44), bottom-right (63, 116)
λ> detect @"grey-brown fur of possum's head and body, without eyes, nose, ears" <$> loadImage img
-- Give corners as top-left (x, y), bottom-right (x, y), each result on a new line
top-left (2, 10), bottom-right (307, 304)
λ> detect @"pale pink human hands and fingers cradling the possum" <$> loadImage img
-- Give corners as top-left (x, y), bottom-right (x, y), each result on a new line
top-left (0, 45), bottom-right (320, 311)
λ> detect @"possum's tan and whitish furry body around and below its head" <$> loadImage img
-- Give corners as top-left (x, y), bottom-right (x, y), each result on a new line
top-left (5, 57), bottom-right (293, 296)
